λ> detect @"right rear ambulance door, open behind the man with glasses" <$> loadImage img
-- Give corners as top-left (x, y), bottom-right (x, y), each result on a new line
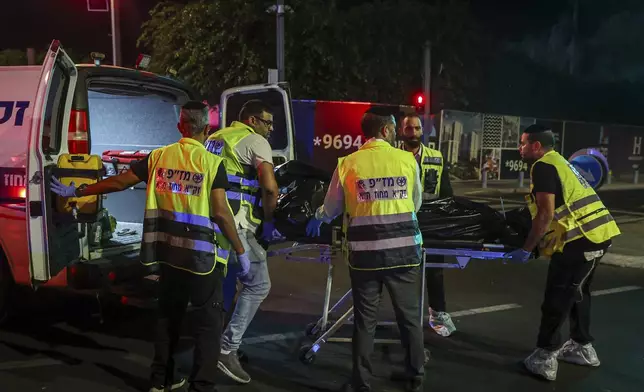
top-left (220, 83), bottom-right (295, 166)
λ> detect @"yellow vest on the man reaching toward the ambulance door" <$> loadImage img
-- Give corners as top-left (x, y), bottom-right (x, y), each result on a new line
top-left (141, 138), bottom-right (228, 275)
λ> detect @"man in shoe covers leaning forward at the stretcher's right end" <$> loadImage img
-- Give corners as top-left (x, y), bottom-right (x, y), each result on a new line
top-left (506, 124), bottom-right (620, 381)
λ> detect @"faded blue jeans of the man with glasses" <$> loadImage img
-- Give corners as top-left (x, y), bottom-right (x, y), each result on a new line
top-left (221, 230), bottom-right (271, 351)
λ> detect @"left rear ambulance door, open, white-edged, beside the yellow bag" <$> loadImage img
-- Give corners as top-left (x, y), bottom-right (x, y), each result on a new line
top-left (27, 40), bottom-right (80, 284)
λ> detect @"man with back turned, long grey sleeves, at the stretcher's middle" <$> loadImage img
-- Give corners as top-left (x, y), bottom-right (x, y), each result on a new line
top-left (306, 108), bottom-right (425, 392)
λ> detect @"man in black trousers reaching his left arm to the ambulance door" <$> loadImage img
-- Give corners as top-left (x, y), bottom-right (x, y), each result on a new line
top-left (52, 101), bottom-right (250, 392)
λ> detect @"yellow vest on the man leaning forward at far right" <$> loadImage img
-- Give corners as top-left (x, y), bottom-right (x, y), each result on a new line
top-left (526, 151), bottom-right (621, 256)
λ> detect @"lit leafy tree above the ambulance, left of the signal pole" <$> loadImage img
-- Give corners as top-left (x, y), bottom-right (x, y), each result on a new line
top-left (137, 0), bottom-right (270, 98)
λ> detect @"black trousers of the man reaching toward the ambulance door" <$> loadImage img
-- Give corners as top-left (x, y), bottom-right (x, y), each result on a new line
top-left (151, 264), bottom-right (224, 392)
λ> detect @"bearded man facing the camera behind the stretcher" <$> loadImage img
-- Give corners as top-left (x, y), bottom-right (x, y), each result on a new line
top-left (400, 114), bottom-right (456, 336)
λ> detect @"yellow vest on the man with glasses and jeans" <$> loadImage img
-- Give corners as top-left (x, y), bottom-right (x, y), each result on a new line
top-left (206, 121), bottom-right (262, 226)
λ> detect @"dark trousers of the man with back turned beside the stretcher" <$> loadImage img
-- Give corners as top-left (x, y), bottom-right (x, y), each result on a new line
top-left (351, 267), bottom-right (425, 389)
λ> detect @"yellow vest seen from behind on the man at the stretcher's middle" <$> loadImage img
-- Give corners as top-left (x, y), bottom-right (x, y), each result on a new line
top-left (338, 139), bottom-right (422, 270)
